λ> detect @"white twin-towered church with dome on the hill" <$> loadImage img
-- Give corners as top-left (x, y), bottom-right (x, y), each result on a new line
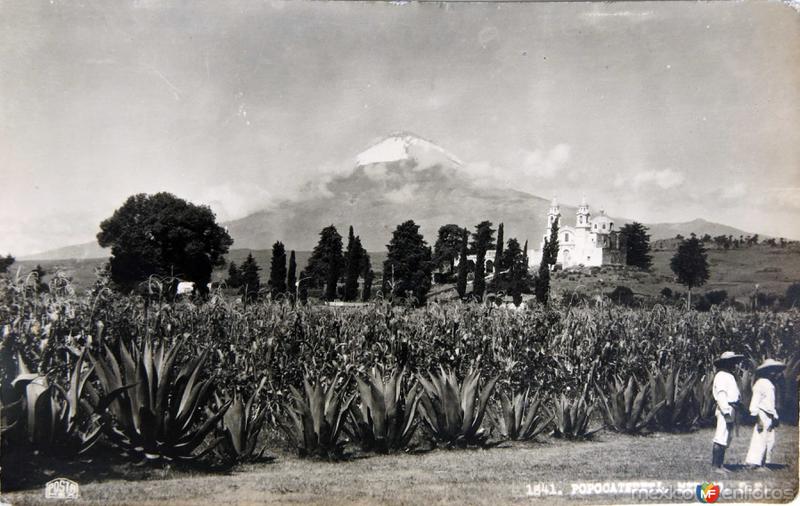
top-left (531, 199), bottom-right (625, 269)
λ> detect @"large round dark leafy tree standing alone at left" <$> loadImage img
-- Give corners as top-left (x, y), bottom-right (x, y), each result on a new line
top-left (97, 192), bottom-right (233, 292)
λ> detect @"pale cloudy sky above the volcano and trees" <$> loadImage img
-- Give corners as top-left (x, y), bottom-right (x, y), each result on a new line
top-left (0, 0), bottom-right (800, 256)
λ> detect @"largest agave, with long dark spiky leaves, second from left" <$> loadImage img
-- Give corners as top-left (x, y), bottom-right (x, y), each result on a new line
top-left (89, 340), bottom-right (230, 462)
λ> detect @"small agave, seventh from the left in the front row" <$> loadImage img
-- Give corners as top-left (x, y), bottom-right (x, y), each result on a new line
top-left (490, 387), bottom-right (553, 441)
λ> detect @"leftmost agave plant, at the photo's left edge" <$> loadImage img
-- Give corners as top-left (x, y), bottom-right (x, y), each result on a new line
top-left (12, 350), bottom-right (129, 456)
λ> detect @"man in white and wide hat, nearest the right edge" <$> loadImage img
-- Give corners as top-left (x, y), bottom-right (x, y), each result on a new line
top-left (745, 358), bottom-right (786, 467)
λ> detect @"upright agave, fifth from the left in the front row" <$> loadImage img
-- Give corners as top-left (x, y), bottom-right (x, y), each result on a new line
top-left (350, 366), bottom-right (419, 453)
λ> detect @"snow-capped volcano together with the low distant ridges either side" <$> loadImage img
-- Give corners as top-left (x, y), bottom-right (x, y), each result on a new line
top-left (20, 133), bottom-right (768, 260)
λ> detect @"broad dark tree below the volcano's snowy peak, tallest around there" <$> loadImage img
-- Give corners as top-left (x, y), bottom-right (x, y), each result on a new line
top-left (383, 220), bottom-right (433, 304)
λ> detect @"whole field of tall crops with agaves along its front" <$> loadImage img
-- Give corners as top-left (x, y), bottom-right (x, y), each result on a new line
top-left (0, 277), bottom-right (800, 488)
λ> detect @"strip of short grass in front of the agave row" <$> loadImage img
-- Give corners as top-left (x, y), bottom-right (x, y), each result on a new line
top-left (2, 426), bottom-right (798, 505)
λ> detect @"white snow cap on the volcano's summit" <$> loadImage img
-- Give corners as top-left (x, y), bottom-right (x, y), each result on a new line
top-left (356, 132), bottom-right (463, 168)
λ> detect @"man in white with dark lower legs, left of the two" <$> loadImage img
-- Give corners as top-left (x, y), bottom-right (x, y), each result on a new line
top-left (711, 351), bottom-right (744, 473)
